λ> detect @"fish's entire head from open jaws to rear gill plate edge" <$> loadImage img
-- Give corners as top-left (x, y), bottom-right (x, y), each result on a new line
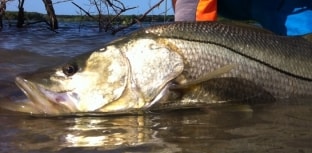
top-left (12, 36), bottom-right (184, 115)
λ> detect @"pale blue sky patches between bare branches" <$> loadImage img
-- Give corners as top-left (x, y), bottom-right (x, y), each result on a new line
top-left (6, 0), bottom-right (173, 15)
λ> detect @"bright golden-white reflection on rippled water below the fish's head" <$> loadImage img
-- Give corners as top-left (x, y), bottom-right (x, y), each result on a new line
top-left (64, 116), bottom-right (149, 148)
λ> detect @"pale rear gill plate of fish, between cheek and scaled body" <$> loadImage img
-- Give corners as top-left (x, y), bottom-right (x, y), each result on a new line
top-left (125, 38), bottom-right (184, 107)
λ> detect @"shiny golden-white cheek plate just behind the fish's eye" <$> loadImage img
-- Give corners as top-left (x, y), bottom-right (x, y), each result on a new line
top-left (70, 46), bottom-right (128, 111)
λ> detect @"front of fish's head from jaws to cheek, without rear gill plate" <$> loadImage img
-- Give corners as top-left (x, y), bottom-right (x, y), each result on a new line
top-left (16, 46), bottom-right (129, 114)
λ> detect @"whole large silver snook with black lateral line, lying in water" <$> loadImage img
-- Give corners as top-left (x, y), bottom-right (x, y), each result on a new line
top-left (3, 22), bottom-right (312, 115)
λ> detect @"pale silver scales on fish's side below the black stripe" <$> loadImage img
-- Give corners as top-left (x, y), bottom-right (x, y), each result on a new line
top-left (158, 38), bottom-right (312, 98)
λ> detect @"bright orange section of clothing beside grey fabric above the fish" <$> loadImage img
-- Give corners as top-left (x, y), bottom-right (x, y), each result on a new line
top-left (196, 0), bottom-right (217, 21)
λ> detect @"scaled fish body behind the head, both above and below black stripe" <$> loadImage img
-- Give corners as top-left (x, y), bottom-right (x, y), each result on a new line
top-left (137, 22), bottom-right (312, 95)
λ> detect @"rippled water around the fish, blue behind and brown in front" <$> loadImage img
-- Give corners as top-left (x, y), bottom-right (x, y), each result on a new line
top-left (0, 24), bottom-right (312, 153)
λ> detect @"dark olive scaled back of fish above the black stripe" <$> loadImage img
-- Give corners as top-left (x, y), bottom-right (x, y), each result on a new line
top-left (137, 22), bottom-right (312, 81)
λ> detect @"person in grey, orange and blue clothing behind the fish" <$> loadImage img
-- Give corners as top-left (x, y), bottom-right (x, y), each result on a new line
top-left (173, 0), bottom-right (312, 36)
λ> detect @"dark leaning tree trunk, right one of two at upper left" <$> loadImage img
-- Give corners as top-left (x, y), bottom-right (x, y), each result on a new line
top-left (42, 0), bottom-right (58, 30)
